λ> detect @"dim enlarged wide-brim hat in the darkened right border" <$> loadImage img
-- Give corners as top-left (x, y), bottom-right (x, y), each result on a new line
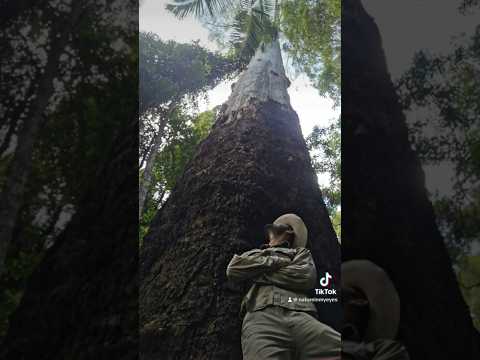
top-left (342, 260), bottom-right (400, 342)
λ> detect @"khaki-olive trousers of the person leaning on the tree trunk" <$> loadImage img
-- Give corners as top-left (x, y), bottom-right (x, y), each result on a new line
top-left (242, 306), bottom-right (342, 360)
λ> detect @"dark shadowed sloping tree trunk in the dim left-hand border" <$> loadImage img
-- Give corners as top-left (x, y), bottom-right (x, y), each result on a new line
top-left (0, 119), bottom-right (138, 360)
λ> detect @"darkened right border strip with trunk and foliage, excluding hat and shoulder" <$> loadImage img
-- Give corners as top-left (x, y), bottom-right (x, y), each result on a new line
top-left (342, 0), bottom-right (480, 360)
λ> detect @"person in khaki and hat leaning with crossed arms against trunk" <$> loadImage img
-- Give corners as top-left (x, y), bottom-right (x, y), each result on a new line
top-left (227, 214), bottom-right (341, 360)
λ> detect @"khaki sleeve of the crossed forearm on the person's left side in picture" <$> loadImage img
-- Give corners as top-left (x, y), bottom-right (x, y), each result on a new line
top-left (227, 250), bottom-right (291, 281)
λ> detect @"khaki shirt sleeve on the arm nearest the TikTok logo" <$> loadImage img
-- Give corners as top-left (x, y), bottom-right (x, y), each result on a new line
top-left (256, 248), bottom-right (317, 291)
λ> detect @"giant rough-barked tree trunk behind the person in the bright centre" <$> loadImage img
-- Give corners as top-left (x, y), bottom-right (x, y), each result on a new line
top-left (140, 42), bottom-right (340, 360)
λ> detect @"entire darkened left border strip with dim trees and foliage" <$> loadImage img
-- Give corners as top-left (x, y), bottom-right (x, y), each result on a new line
top-left (0, 0), bottom-right (138, 359)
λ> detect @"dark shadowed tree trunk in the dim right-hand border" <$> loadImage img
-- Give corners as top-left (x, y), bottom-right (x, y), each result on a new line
top-left (342, 0), bottom-right (480, 360)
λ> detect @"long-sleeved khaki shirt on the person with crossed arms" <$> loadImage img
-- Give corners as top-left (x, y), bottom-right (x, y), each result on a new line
top-left (227, 247), bottom-right (317, 316)
